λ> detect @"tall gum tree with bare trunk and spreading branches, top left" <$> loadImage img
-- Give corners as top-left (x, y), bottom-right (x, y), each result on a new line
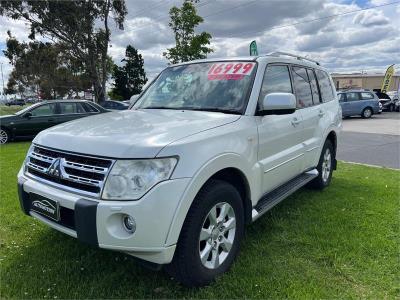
top-left (0, 0), bottom-right (127, 102)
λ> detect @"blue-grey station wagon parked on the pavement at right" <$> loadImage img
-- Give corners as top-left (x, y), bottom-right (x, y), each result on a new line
top-left (338, 91), bottom-right (379, 119)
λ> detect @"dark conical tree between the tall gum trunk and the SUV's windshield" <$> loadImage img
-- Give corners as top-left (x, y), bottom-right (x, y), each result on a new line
top-left (110, 45), bottom-right (147, 100)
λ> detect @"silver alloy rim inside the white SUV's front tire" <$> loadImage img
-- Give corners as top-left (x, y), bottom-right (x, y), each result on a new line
top-left (199, 202), bottom-right (236, 269)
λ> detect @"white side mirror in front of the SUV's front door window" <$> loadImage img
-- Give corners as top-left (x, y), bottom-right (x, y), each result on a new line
top-left (260, 93), bottom-right (296, 115)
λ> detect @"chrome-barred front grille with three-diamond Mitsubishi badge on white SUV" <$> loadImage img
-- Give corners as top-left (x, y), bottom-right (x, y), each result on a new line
top-left (26, 146), bottom-right (113, 197)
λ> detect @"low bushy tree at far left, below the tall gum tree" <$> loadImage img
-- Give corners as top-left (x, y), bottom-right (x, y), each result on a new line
top-left (3, 32), bottom-right (91, 98)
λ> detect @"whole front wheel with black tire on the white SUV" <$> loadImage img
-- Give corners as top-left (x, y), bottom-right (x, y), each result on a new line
top-left (165, 180), bottom-right (244, 287)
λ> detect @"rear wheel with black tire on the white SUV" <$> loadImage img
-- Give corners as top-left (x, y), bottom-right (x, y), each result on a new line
top-left (308, 140), bottom-right (335, 190)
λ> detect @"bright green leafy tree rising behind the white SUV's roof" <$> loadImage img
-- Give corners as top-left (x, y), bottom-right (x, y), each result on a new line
top-left (163, 0), bottom-right (213, 64)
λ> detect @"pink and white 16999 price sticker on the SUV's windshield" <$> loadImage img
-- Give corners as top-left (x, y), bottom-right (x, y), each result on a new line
top-left (207, 62), bottom-right (256, 80)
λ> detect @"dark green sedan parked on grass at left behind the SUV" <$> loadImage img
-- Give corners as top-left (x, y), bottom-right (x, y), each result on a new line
top-left (0, 100), bottom-right (108, 144)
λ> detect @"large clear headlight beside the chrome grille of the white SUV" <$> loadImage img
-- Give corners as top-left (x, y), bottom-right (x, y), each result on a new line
top-left (102, 157), bottom-right (177, 200)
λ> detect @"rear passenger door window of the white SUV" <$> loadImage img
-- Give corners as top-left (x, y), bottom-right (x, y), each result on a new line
top-left (292, 67), bottom-right (313, 108)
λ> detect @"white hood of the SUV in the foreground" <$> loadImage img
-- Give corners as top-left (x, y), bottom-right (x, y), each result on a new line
top-left (33, 109), bottom-right (240, 158)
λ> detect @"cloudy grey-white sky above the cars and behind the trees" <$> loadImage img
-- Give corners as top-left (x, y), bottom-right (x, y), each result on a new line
top-left (0, 0), bottom-right (400, 81)
